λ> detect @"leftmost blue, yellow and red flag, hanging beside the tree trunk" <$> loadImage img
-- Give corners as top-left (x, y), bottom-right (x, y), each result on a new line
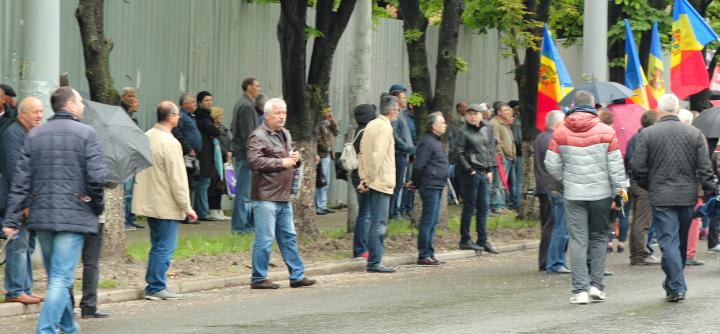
top-left (535, 24), bottom-right (573, 131)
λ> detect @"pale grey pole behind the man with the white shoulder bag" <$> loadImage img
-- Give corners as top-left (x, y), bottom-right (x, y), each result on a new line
top-left (345, 0), bottom-right (373, 233)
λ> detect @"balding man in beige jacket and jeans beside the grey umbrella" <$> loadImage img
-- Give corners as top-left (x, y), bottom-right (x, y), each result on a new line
top-left (132, 101), bottom-right (197, 299)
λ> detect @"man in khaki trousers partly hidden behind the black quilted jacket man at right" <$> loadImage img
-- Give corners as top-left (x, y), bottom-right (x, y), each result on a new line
top-left (625, 110), bottom-right (660, 266)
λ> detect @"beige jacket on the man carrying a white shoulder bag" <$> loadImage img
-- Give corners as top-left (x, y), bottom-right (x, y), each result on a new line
top-left (358, 115), bottom-right (396, 195)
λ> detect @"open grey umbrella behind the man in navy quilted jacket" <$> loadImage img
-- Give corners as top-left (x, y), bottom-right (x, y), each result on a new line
top-left (82, 100), bottom-right (152, 183)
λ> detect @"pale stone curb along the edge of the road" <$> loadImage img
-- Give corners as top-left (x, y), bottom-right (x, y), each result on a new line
top-left (0, 241), bottom-right (540, 317)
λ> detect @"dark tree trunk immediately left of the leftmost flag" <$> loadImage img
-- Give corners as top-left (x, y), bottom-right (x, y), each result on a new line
top-left (515, 0), bottom-right (550, 220)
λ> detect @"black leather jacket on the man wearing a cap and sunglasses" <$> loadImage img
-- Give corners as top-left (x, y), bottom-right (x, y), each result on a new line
top-left (453, 122), bottom-right (497, 174)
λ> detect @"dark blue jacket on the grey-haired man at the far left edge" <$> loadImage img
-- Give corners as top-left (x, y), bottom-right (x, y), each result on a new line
top-left (0, 118), bottom-right (28, 216)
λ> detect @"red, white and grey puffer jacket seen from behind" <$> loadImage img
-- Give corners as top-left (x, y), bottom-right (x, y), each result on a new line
top-left (545, 104), bottom-right (625, 201)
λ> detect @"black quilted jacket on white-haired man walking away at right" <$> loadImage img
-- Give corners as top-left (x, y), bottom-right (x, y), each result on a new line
top-left (631, 115), bottom-right (714, 206)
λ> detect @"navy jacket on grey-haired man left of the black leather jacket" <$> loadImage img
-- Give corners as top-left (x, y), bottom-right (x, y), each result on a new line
top-left (412, 132), bottom-right (450, 190)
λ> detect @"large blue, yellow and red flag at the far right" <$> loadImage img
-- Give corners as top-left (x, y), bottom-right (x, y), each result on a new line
top-left (670, 0), bottom-right (718, 100)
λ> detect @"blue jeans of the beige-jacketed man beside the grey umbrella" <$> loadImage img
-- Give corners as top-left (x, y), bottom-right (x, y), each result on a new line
top-left (145, 217), bottom-right (180, 295)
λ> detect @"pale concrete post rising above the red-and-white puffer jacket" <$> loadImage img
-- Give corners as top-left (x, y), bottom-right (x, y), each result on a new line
top-left (582, 0), bottom-right (608, 84)
